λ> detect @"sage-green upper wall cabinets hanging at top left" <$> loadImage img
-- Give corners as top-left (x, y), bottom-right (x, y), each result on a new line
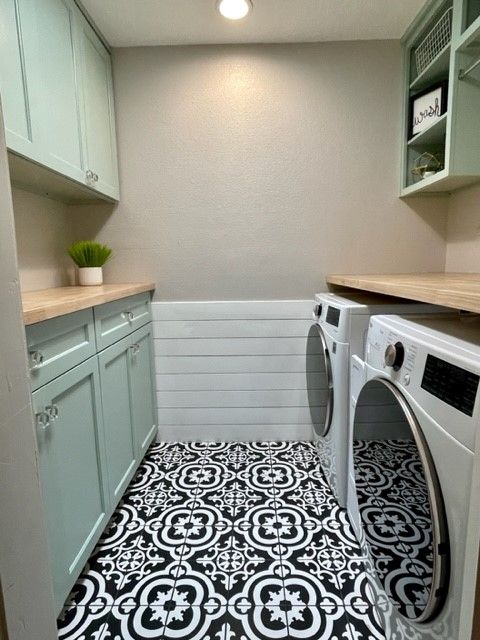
top-left (0, 0), bottom-right (119, 200)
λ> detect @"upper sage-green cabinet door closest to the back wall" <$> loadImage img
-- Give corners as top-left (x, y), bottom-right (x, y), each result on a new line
top-left (79, 17), bottom-right (119, 199)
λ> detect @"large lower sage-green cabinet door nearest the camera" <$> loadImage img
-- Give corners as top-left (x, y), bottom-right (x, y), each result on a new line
top-left (33, 358), bottom-right (109, 612)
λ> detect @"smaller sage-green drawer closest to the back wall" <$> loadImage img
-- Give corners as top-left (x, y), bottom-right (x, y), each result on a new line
top-left (94, 292), bottom-right (152, 351)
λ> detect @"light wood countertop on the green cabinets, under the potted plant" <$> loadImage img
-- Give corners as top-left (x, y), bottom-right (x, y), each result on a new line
top-left (22, 282), bottom-right (155, 325)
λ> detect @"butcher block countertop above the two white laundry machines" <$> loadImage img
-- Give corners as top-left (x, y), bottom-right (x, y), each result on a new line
top-left (327, 273), bottom-right (480, 313)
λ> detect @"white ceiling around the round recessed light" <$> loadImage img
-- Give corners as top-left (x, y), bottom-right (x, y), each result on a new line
top-left (82, 0), bottom-right (425, 47)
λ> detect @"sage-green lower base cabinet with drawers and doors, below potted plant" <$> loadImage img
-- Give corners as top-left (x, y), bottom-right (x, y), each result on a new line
top-left (26, 294), bottom-right (156, 613)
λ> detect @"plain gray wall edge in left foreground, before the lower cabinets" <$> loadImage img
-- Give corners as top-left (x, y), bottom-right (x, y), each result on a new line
top-left (0, 110), bottom-right (57, 640)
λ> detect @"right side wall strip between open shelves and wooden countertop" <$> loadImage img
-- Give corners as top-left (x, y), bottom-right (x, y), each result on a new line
top-left (446, 185), bottom-right (480, 273)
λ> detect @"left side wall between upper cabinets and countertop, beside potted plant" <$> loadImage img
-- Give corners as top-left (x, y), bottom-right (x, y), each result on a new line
top-left (12, 189), bottom-right (75, 291)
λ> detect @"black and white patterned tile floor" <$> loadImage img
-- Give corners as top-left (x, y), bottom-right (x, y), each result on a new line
top-left (58, 442), bottom-right (384, 640)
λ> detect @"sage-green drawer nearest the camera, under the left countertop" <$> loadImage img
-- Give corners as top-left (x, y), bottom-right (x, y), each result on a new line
top-left (25, 309), bottom-right (96, 391)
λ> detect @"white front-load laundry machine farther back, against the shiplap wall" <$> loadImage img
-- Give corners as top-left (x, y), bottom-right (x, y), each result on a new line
top-left (306, 293), bottom-right (454, 507)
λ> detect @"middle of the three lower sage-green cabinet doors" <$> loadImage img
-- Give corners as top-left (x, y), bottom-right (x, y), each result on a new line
top-left (98, 336), bottom-right (136, 504)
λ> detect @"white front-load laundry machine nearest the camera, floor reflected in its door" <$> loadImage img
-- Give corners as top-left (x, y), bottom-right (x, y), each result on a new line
top-left (348, 316), bottom-right (480, 640)
